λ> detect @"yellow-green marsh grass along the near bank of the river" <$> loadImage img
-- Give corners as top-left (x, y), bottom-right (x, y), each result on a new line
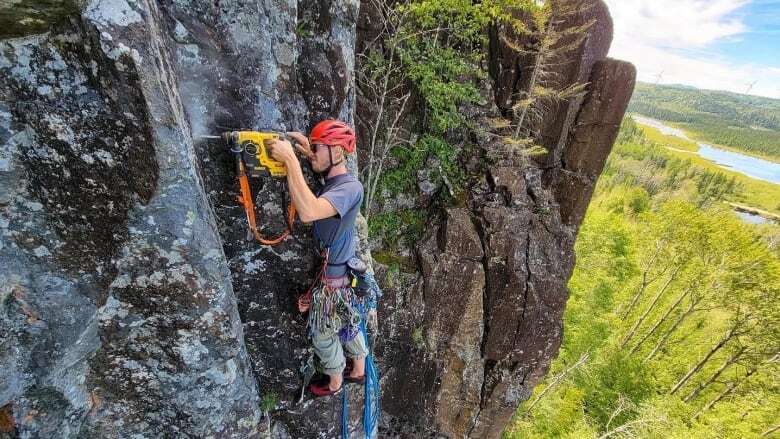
top-left (639, 125), bottom-right (780, 214)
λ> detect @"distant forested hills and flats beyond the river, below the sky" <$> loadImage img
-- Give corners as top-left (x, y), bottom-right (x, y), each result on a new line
top-left (628, 82), bottom-right (780, 158)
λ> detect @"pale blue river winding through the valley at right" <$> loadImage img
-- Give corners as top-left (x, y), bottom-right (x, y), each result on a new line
top-left (631, 115), bottom-right (780, 184)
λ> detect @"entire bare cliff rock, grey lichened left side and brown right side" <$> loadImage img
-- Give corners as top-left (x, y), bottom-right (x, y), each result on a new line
top-left (0, 0), bottom-right (634, 438)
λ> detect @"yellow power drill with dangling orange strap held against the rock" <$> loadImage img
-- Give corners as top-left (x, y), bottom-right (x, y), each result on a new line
top-left (219, 131), bottom-right (295, 245)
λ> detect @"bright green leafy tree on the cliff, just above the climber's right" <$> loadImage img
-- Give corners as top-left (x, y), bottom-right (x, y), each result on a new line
top-left (356, 0), bottom-right (494, 219)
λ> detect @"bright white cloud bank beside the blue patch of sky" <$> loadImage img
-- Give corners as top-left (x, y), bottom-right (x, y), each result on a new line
top-left (606, 0), bottom-right (780, 98)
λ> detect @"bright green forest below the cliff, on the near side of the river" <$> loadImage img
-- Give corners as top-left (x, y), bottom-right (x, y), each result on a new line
top-left (505, 119), bottom-right (780, 439)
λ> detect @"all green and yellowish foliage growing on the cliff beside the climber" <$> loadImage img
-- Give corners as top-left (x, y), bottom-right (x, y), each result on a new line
top-left (358, 0), bottom-right (589, 247)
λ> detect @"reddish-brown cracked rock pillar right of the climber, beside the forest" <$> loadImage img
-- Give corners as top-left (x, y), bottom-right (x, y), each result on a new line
top-left (365, 1), bottom-right (636, 438)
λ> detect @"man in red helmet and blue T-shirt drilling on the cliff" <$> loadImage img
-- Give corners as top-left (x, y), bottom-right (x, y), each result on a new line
top-left (269, 120), bottom-right (368, 396)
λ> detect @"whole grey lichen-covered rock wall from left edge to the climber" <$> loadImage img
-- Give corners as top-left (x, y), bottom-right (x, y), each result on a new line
top-left (0, 0), bottom-right (368, 437)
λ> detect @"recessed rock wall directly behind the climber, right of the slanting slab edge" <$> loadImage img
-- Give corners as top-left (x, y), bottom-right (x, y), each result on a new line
top-left (166, 0), bottom-right (362, 438)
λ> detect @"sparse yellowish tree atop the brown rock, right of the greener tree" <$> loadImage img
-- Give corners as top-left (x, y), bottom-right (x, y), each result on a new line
top-left (499, 0), bottom-right (594, 155)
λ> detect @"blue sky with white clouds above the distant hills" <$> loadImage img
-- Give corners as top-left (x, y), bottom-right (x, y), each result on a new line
top-left (605, 0), bottom-right (780, 98)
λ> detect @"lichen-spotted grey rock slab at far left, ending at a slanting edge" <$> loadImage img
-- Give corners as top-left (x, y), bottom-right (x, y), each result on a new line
top-left (0, 1), bottom-right (260, 437)
